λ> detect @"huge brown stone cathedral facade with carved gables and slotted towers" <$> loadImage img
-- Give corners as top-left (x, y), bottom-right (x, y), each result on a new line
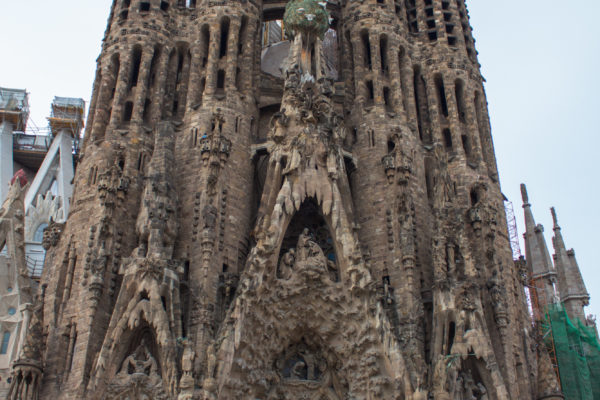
top-left (9, 0), bottom-right (562, 400)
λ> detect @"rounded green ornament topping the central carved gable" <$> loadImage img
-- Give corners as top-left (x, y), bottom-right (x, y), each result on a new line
top-left (283, 0), bottom-right (329, 39)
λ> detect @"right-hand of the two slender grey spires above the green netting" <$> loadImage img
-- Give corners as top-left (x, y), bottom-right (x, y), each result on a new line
top-left (550, 207), bottom-right (590, 322)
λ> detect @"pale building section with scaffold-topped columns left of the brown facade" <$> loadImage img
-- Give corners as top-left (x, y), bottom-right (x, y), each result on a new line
top-left (0, 88), bottom-right (85, 398)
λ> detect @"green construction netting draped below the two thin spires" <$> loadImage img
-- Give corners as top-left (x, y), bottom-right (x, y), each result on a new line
top-left (546, 304), bottom-right (600, 400)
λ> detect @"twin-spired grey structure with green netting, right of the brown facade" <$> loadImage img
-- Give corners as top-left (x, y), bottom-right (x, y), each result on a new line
top-left (507, 185), bottom-right (600, 400)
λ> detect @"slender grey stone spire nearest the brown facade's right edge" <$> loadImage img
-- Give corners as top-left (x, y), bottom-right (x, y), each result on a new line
top-left (521, 184), bottom-right (556, 309)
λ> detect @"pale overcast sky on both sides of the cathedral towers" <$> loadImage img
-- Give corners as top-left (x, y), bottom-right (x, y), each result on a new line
top-left (0, 0), bottom-right (600, 315)
